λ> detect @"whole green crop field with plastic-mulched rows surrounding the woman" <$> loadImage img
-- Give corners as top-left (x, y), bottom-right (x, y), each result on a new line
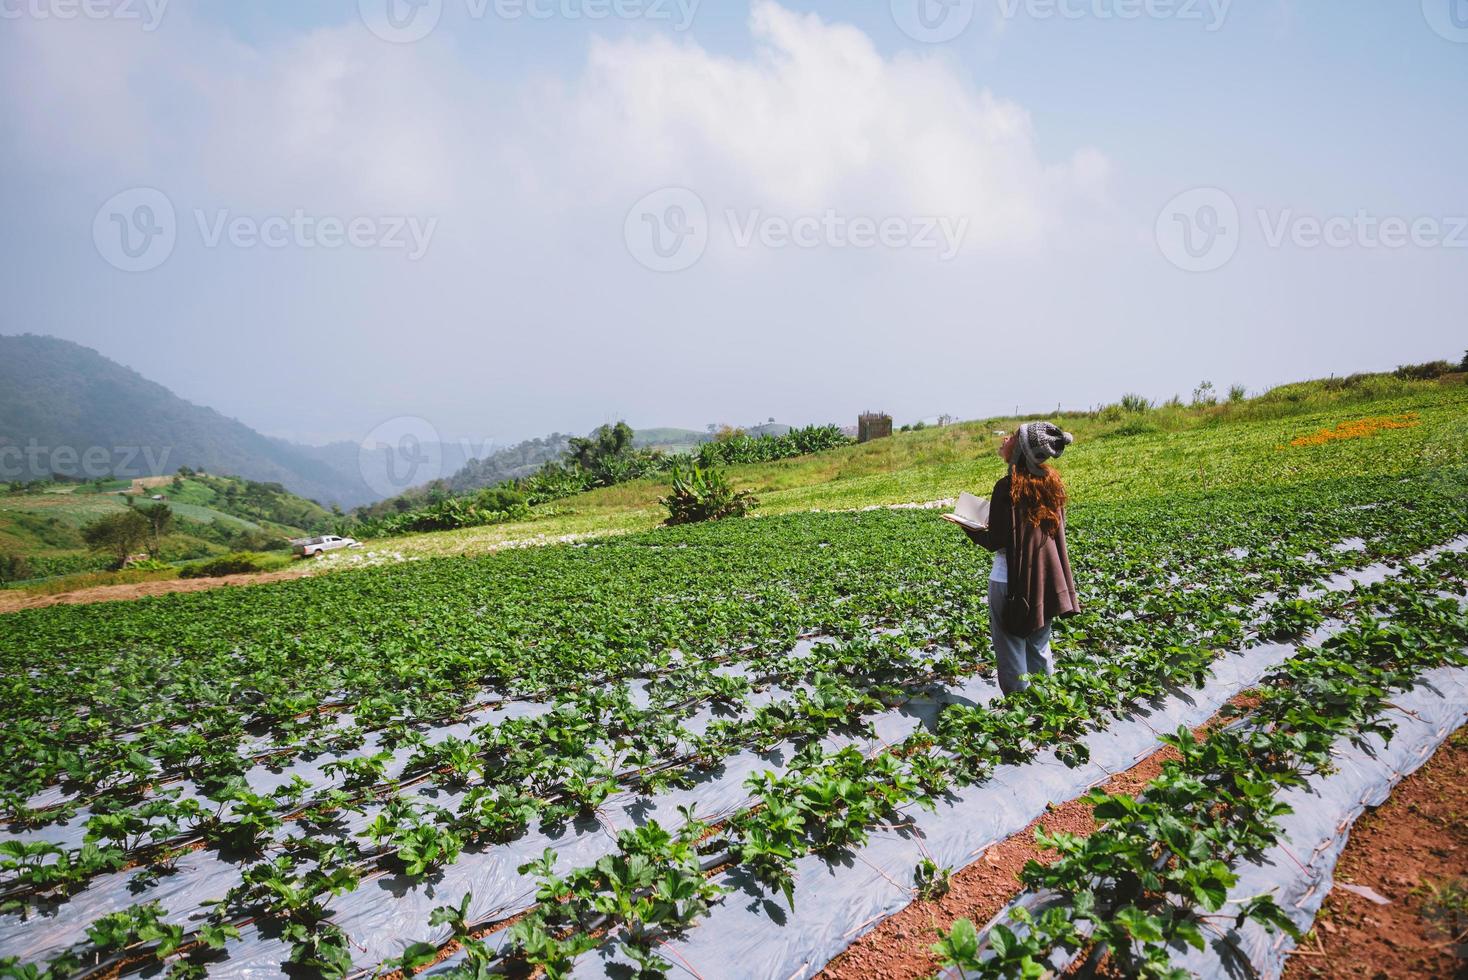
top-left (0, 386), bottom-right (1468, 977)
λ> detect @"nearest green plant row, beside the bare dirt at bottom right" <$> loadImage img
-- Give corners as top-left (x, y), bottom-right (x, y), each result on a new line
top-left (935, 553), bottom-right (1468, 980)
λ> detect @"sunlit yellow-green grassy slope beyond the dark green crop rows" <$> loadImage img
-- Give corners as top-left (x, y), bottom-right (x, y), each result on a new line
top-left (371, 376), bottom-right (1468, 556)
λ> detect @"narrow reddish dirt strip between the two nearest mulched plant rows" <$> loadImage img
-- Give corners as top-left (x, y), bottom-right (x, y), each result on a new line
top-left (819, 694), bottom-right (1252, 980)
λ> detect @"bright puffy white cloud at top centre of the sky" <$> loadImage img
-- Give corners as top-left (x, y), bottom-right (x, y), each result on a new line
top-left (558, 0), bottom-right (1108, 245)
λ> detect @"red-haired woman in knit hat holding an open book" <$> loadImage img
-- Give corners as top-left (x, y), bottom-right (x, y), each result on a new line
top-left (945, 423), bottom-right (1080, 694)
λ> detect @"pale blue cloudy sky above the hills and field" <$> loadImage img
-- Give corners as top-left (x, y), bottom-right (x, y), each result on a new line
top-left (0, 0), bottom-right (1468, 442)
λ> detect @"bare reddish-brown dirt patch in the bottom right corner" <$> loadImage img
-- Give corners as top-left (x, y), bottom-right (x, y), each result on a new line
top-left (1285, 729), bottom-right (1468, 980)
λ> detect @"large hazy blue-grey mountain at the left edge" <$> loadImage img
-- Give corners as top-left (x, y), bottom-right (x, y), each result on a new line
top-left (0, 334), bottom-right (379, 508)
